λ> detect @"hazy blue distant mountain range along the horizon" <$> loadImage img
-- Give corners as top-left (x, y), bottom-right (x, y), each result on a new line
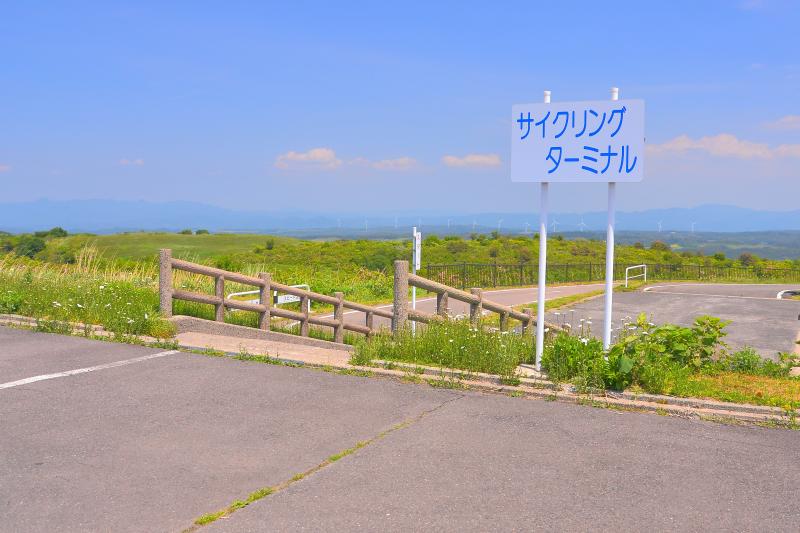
top-left (0, 200), bottom-right (800, 236)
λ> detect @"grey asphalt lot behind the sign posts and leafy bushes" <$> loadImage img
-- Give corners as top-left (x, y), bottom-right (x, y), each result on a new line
top-left (564, 283), bottom-right (800, 357)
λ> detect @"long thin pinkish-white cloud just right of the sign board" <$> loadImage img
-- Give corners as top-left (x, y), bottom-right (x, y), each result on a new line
top-left (647, 133), bottom-right (800, 159)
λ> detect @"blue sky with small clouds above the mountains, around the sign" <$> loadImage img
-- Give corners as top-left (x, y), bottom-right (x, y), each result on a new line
top-left (0, 0), bottom-right (800, 213)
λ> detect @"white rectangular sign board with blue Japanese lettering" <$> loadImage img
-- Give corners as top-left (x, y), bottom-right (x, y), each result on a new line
top-left (511, 100), bottom-right (644, 183)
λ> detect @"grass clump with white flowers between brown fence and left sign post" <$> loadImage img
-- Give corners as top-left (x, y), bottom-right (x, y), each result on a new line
top-left (351, 321), bottom-right (533, 376)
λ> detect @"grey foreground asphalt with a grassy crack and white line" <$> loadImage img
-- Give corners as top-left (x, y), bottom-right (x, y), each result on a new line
top-left (0, 327), bottom-right (800, 532)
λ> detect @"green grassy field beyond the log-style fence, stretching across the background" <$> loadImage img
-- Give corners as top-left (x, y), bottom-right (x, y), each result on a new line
top-left (0, 228), bottom-right (794, 332)
